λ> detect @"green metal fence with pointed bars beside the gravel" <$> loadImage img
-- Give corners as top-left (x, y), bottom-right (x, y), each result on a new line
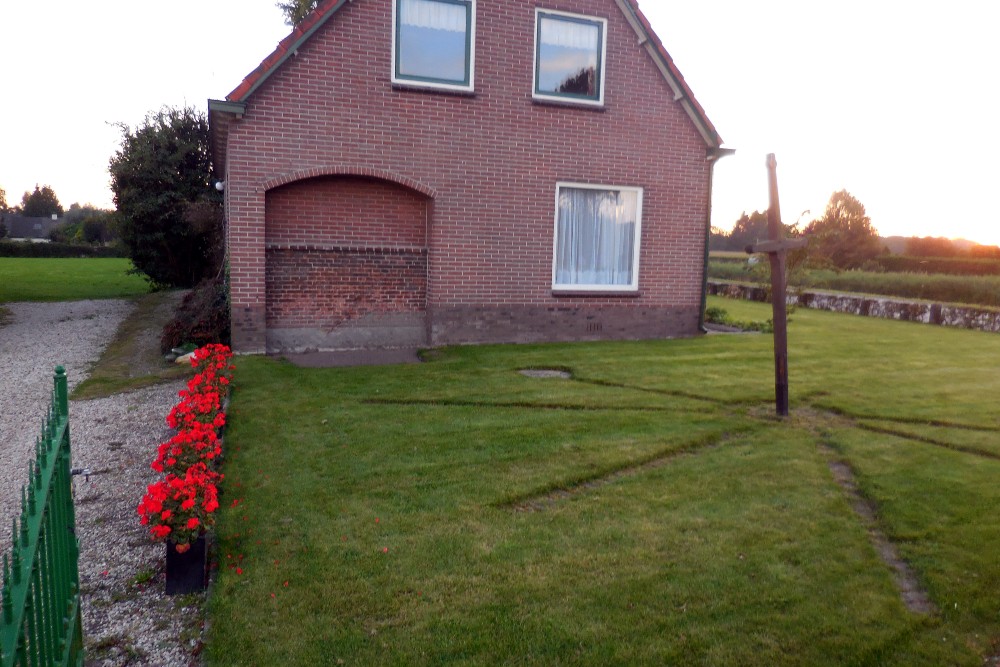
top-left (0, 366), bottom-right (83, 667)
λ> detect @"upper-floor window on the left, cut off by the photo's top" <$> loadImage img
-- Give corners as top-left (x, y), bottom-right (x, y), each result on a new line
top-left (392, 0), bottom-right (476, 91)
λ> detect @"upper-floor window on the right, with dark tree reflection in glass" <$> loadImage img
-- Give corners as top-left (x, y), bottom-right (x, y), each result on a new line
top-left (534, 9), bottom-right (607, 105)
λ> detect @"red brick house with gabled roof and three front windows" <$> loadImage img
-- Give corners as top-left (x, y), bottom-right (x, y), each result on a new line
top-left (209, 0), bottom-right (730, 352)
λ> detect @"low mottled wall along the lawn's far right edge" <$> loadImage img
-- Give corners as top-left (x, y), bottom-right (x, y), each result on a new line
top-left (708, 280), bottom-right (1000, 333)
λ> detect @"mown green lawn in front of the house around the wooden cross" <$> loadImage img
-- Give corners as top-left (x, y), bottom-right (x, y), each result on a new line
top-left (206, 299), bottom-right (1000, 665)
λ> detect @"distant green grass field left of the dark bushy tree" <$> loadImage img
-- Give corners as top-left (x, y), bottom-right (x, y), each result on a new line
top-left (0, 257), bottom-right (149, 303)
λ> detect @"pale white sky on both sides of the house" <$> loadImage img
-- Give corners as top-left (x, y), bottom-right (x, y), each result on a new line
top-left (0, 0), bottom-right (1000, 244)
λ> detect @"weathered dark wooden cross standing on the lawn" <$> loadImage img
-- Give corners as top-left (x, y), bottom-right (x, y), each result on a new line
top-left (746, 153), bottom-right (806, 417)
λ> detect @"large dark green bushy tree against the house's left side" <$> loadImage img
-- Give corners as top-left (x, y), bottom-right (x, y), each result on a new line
top-left (110, 107), bottom-right (223, 287)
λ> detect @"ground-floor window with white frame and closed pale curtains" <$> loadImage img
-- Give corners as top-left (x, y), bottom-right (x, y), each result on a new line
top-left (552, 183), bottom-right (642, 291)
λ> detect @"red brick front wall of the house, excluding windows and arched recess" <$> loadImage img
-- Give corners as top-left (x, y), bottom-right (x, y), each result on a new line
top-left (227, 0), bottom-right (709, 351)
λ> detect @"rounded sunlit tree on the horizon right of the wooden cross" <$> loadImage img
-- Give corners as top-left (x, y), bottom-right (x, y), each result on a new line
top-left (805, 190), bottom-right (885, 269)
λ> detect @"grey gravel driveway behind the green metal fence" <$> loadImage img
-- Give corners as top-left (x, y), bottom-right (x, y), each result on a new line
top-left (0, 301), bottom-right (204, 667)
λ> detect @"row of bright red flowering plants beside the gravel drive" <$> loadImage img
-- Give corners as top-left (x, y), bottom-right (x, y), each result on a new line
top-left (138, 344), bottom-right (233, 553)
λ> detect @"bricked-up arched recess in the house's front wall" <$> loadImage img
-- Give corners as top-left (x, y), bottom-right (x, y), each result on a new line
top-left (264, 170), bottom-right (431, 352)
